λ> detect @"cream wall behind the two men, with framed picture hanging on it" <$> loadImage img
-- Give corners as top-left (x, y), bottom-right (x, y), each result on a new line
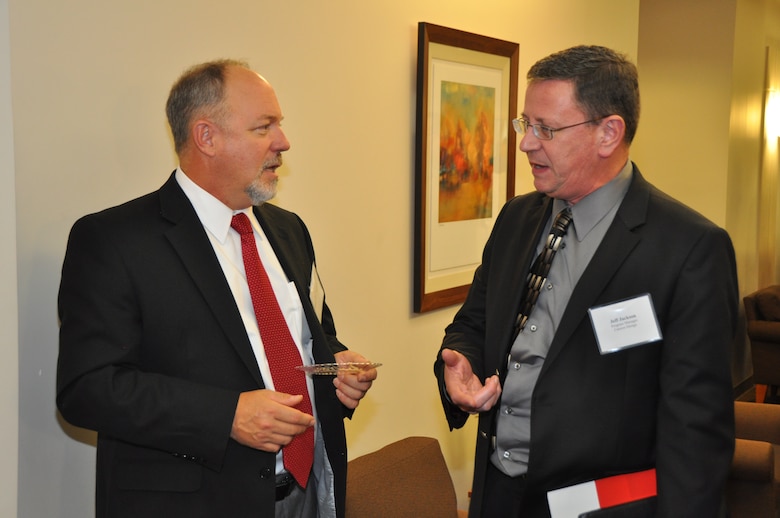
top-left (7, 0), bottom-right (639, 518)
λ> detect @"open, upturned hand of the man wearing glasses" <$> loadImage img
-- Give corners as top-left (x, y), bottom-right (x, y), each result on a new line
top-left (441, 349), bottom-right (501, 414)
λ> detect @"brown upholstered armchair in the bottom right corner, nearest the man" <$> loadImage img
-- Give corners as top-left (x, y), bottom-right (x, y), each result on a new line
top-left (726, 401), bottom-right (780, 518)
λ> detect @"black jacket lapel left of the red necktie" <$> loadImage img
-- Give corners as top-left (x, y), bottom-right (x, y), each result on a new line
top-left (160, 177), bottom-right (264, 387)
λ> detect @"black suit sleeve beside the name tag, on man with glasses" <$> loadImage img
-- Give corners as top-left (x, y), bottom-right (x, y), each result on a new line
top-left (656, 227), bottom-right (739, 517)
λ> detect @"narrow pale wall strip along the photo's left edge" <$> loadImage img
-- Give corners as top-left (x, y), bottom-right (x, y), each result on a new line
top-left (0, 0), bottom-right (19, 516)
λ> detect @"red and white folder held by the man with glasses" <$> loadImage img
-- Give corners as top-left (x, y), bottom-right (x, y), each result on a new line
top-left (547, 469), bottom-right (657, 518)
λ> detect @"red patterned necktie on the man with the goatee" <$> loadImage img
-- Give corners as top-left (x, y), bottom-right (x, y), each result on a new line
top-left (230, 213), bottom-right (314, 488)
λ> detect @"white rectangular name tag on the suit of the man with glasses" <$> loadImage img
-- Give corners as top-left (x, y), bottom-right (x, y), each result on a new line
top-left (588, 293), bottom-right (662, 354)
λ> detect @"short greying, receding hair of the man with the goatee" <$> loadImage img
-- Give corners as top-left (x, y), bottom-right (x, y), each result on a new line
top-left (165, 59), bottom-right (249, 153)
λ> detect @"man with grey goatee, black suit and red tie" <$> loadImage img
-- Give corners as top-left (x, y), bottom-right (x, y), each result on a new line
top-left (57, 60), bottom-right (376, 518)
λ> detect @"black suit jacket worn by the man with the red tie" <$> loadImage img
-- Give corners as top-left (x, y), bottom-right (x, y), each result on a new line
top-left (57, 176), bottom-right (349, 518)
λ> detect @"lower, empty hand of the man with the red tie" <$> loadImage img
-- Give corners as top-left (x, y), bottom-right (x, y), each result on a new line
top-left (230, 390), bottom-right (314, 453)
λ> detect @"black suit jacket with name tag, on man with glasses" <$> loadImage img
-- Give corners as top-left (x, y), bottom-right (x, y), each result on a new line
top-left (435, 167), bottom-right (739, 518)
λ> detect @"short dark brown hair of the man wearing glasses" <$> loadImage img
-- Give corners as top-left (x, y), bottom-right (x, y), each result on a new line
top-left (527, 45), bottom-right (639, 144)
